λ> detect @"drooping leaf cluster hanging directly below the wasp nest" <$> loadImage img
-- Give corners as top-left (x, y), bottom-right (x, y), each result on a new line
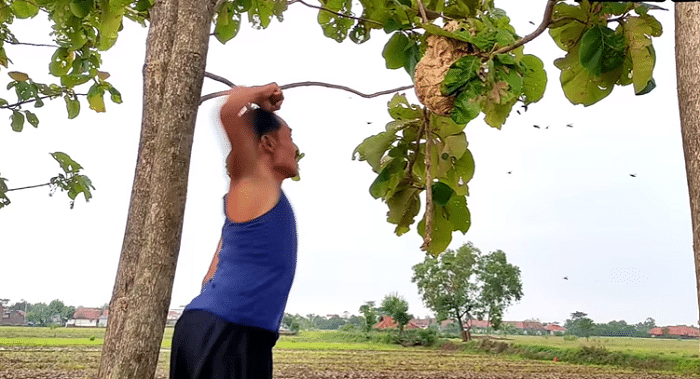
top-left (353, 94), bottom-right (474, 255)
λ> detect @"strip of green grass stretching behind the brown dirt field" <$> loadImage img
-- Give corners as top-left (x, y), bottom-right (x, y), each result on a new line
top-left (0, 327), bottom-right (700, 374)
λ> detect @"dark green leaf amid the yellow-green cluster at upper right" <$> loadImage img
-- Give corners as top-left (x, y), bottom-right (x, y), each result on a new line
top-left (579, 25), bottom-right (626, 76)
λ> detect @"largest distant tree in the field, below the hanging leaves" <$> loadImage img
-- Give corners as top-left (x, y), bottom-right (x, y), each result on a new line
top-left (412, 242), bottom-right (523, 341)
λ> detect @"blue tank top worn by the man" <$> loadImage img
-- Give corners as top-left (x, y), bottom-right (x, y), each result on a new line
top-left (185, 190), bottom-right (297, 333)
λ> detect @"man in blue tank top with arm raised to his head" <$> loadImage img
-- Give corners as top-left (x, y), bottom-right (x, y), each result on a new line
top-left (170, 83), bottom-right (298, 379)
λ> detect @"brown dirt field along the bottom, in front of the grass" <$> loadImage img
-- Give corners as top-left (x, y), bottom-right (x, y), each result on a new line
top-left (0, 346), bottom-right (688, 379)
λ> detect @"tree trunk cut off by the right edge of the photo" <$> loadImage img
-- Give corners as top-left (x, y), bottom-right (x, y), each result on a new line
top-left (675, 2), bottom-right (700, 354)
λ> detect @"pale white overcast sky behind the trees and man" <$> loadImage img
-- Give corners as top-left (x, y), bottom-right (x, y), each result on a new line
top-left (0, 0), bottom-right (698, 325)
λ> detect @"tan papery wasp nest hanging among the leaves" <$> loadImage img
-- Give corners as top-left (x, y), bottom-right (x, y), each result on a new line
top-left (414, 21), bottom-right (474, 116)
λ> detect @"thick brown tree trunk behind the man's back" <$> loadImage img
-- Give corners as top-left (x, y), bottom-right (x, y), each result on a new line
top-left (98, 0), bottom-right (216, 379)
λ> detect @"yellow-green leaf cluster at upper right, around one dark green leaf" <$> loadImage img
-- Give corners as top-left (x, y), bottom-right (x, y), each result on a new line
top-left (549, 1), bottom-right (662, 106)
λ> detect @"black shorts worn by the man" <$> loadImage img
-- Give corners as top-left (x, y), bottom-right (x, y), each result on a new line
top-left (170, 310), bottom-right (278, 379)
